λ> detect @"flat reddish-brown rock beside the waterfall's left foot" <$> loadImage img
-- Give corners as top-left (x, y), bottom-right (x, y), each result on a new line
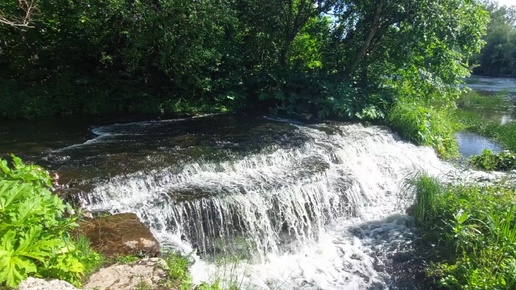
top-left (75, 213), bottom-right (160, 257)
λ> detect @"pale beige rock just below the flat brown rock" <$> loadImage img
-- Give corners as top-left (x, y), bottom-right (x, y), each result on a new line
top-left (82, 258), bottom-right (168, 290)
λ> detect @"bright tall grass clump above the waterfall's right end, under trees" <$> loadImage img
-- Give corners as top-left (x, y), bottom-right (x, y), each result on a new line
top-left (388, 102), bottom-right (458, 158)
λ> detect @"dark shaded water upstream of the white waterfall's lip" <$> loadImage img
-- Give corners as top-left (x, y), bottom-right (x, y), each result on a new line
top-left (0, 115), bottom-right (306, 194)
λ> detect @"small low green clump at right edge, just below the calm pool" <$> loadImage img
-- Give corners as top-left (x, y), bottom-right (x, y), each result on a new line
top-left (470, 150), bottom-right (516, 171)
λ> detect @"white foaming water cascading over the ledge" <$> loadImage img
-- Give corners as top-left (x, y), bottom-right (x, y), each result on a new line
top-left (64, 116), bottom-right (464, 289)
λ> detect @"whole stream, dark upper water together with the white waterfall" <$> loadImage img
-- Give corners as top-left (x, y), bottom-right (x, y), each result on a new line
top-left (0, 76), bottom-right (512, 289)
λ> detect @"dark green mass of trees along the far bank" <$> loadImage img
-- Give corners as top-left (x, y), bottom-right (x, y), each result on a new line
top-left (0, 0), bottom-right (488, 119)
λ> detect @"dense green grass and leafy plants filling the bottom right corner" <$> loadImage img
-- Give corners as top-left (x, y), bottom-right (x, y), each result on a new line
top-left (415, 177), bottom-right (516, 290)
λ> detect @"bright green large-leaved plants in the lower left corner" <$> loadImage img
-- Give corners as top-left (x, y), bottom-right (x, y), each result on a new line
top-left (0, 156), bottom-right (94, 287)
